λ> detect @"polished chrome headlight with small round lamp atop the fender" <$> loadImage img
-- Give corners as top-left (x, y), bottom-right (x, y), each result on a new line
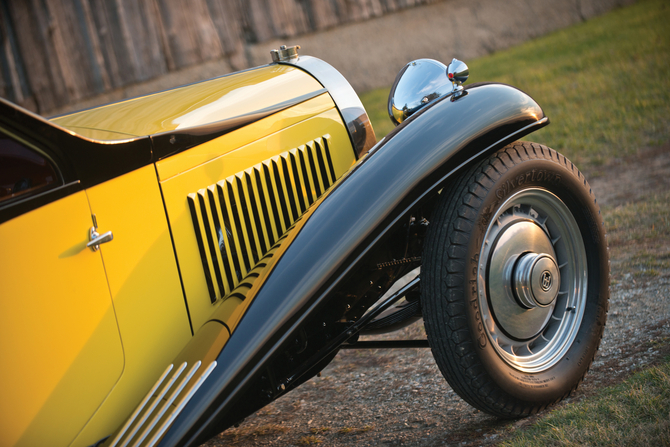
top-left (388, 59), bottom-right (469, 126)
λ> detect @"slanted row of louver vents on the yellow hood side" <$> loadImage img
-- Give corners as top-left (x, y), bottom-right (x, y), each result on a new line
top-left (188, 135), bottom-right (335, 302)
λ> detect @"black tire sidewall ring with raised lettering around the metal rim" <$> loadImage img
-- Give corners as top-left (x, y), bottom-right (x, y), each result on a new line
top-left (464, 151), bottom-right (609, 404)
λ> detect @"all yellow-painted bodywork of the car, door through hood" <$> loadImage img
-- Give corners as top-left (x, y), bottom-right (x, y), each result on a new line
top-left (0, 61), bottom-right (356, 446)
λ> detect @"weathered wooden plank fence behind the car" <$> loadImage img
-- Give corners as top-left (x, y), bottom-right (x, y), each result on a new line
top-left (0, 0), bottom-right (440, 113)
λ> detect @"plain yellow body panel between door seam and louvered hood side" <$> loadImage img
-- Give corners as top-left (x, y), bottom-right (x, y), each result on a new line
top-left (74, 165), bottom-right (191, 446)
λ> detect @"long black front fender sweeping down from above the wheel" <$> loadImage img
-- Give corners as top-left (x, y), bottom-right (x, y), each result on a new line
top-left (159, 79), bottom-right (549, 446)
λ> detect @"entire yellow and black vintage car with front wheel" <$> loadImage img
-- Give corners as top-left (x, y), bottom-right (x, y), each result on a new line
top-left (0, 47), bottom-right (609, 446)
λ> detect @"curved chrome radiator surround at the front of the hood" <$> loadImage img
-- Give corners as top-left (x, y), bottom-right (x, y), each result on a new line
top-left (278, 56), bottom-right (377, 158)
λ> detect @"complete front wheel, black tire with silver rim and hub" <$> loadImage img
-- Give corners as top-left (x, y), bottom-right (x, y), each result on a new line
top-left (421, 142), bottom-right (609, 418)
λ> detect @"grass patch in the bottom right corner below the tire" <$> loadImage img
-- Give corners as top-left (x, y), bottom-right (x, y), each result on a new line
top-left (500, 359), bottom-right (670, 447)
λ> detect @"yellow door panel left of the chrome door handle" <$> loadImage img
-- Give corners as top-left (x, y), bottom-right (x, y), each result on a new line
top-left (0, 191), bottom-right (123, 446)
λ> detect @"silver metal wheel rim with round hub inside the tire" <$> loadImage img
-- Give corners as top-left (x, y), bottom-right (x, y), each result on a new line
top-left (477, 188), bottom-right (587, 373)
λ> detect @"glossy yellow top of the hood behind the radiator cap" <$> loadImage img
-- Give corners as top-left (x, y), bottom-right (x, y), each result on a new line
top-left (52, 65), bottom-right (323, 140)
